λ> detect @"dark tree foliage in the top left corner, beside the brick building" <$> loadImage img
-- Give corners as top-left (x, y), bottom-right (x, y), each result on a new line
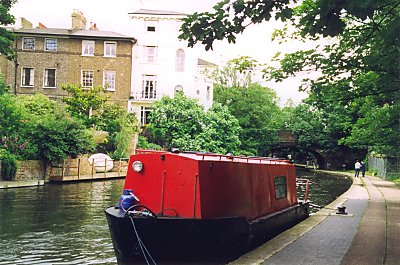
top-left (0, 0), bottom-right (17, 60)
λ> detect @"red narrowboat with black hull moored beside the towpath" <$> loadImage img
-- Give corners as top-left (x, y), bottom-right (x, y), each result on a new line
top-left (105, 150), bottom-right (309, 264)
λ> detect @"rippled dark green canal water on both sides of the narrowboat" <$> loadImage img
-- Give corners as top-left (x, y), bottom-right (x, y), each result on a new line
top-left (0, 168), bottom-right (351, 265)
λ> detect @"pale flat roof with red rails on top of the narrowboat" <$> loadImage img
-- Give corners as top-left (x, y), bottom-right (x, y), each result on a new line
top-left (136, 149), bottom-right (290, 165)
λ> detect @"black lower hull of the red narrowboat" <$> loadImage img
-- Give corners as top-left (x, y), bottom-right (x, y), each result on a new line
top-left (105, 204), bottom-right (308, 265)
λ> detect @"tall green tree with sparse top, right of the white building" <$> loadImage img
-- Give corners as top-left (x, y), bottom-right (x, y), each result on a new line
top-left (210, 56), bottom-right (280, 156)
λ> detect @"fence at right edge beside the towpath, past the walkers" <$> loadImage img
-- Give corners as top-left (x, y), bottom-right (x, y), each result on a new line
top-left (368, 155), bottom-right (400, 180)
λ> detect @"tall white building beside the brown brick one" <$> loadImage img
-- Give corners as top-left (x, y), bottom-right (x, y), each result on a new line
top-left (128, 9), bottom-right (213, 125)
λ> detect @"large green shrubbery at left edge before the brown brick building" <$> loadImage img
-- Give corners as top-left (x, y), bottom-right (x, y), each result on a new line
top-left (0, 94), bottom-right (94, 161)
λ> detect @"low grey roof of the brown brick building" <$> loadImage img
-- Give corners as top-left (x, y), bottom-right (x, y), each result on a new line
top-left (13, 28), bottom-right (136, 41)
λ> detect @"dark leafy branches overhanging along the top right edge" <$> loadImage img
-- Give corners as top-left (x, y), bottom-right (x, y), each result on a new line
top-left (179, 0), bottom-right (399, 50)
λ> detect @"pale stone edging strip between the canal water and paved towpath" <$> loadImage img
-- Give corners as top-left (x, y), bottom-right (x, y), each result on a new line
top-left (228, 170), bottom-right (358, 265)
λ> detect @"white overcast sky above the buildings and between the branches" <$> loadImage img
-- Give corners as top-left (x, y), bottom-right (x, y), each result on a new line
top-left (11, 0), bottom-right (305, 104)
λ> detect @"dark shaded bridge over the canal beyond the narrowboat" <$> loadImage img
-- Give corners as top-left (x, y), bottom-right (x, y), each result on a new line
top-left (271, 130), bottom-right (345, 169)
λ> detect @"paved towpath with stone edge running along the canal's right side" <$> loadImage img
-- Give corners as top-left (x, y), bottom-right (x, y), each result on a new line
top-left (230, 173), bottom-right (400, 265)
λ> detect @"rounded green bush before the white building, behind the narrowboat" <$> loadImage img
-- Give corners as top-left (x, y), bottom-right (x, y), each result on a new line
top-left (145, 94), bottom-right (240, 153)
